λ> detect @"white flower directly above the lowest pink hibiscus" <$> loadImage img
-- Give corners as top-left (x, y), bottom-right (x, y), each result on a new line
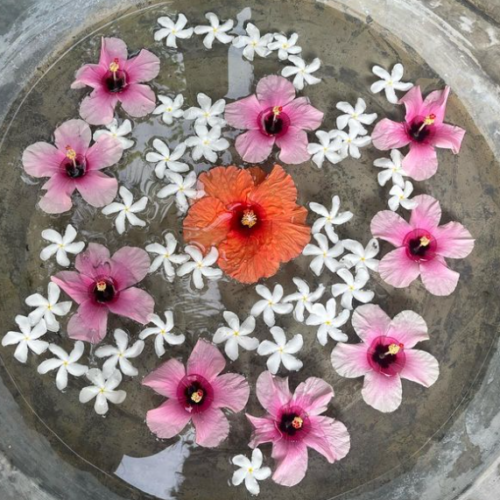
top-left (257, 326), bottom-right (304, 375)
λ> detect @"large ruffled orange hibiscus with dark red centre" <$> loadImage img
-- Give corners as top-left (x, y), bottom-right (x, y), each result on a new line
top-left (184, 165), bottom-right (311, 283)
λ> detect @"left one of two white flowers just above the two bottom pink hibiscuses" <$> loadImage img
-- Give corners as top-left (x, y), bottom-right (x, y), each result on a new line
top-left (213, 311), bottom-right (259, 361)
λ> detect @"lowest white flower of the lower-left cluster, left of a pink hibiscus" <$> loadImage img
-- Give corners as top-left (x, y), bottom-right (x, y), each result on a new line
top-left (79, 368), bottom-right (127, 415)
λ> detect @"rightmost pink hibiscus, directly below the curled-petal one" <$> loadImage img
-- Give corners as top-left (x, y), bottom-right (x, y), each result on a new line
top-left (371, 194), bottom-right (474, 295)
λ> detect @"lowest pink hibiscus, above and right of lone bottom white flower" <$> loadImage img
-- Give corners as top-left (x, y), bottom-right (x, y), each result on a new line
top-left (247, 371), bottom-right (351, 486)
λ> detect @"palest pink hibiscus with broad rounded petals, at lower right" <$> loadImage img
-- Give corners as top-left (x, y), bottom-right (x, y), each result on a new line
top-left (332, 304), bottom-right (439, 413)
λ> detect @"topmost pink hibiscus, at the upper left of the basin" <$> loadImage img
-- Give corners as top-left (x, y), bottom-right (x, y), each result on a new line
top-left (71, 38), bottom-right (160, 125)
